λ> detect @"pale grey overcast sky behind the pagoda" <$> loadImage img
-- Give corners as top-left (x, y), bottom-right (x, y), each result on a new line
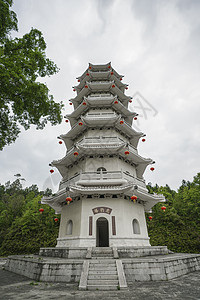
top-left (0, 0), bottom-right (200, 192)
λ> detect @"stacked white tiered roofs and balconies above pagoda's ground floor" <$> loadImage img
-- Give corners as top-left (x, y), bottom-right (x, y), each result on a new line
top-left (43, 63), bottom-right (165, 212)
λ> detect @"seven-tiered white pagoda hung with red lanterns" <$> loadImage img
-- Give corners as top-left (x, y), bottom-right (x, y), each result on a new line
top-left (42, 63), bottom-right (165, 247)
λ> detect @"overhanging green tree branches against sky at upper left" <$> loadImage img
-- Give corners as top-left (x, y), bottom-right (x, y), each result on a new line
top-left (0, 0), bottom-right (63, 150)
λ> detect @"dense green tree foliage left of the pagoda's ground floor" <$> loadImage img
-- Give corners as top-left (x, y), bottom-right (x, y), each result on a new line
top-left (0, 179), bottom-right (59, 255)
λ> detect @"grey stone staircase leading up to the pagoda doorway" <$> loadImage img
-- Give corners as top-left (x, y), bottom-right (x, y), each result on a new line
top-left (79, 247), bottom-right (127, 290)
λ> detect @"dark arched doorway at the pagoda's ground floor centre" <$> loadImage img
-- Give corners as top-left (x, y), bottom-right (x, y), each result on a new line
top-left (96, 217), bottom-right (109, 247)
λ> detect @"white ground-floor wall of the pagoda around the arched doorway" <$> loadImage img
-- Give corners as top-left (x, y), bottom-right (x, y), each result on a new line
top-left (57, 198), bottom-right (150, 247)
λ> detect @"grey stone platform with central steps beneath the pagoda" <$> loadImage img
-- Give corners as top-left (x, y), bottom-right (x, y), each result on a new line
top-left (5, 247), bottom-right (200, 290)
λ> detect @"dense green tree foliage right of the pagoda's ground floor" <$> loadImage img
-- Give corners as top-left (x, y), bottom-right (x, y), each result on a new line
top-left (147, 173), bottom-right (200, 253)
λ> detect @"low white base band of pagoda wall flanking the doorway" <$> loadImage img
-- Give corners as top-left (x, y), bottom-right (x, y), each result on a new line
top-left (56, 236), bottom-right (151, 248)
